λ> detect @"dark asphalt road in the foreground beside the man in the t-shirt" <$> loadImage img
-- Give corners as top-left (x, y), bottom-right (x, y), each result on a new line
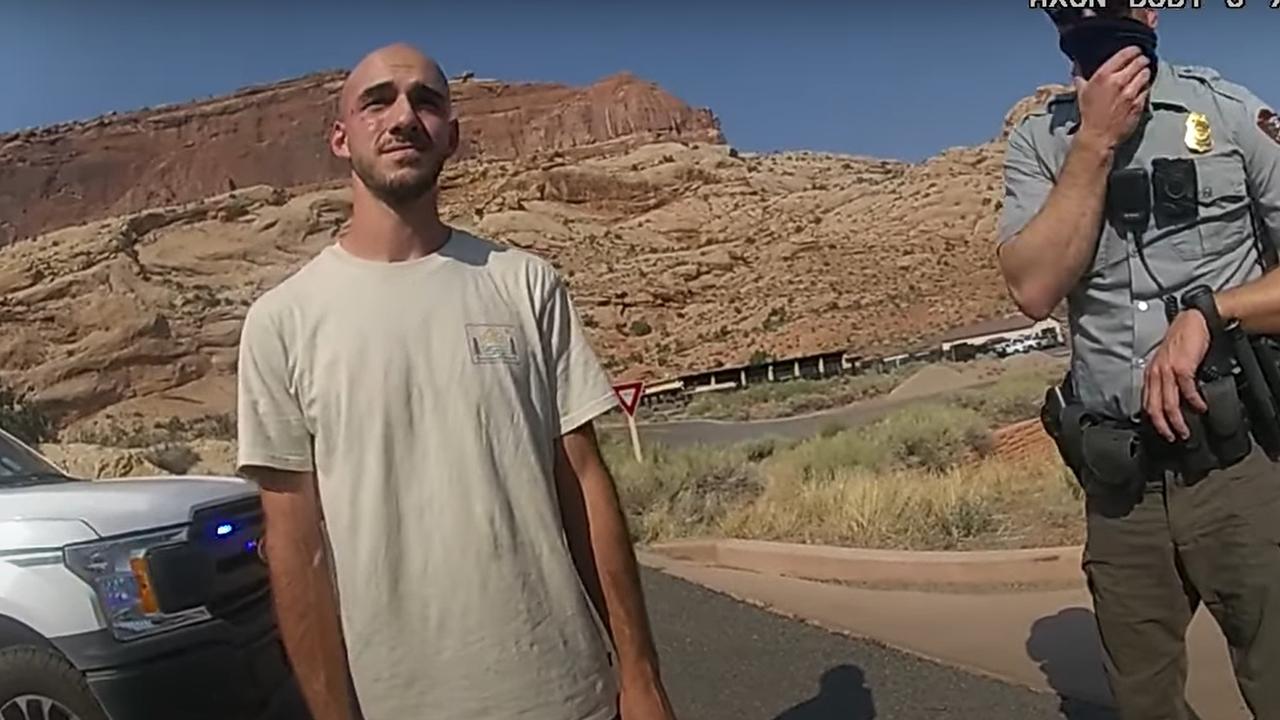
top-left (643, 569), bottom-right (1115, 720)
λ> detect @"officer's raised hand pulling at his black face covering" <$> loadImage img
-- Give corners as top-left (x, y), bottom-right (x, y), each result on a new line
top-left (1075, 46), bottom-right (1155, 149)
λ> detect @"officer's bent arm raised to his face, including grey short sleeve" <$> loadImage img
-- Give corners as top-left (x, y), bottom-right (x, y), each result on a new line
top-left (997, 47), bottom-right (1149, 315)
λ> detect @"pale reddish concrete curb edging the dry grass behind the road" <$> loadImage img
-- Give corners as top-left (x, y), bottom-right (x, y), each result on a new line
top-left (648, 539), bottom-right (1084, 585)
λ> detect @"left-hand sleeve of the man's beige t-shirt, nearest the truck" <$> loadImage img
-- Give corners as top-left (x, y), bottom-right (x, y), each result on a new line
top-left (236, 304), bottom-right (314, 473)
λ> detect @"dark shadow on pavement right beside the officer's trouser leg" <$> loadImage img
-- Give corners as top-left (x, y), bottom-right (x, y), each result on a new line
top-left (1027, 607), bottom-right (1119, 720)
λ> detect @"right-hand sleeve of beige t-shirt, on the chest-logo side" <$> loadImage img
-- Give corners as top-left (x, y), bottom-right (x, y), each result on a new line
top-left (540, 272), bottom-right (617, 434)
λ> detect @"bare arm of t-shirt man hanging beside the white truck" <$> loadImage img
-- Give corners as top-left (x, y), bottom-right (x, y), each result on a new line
top-left (242, 466), bottom-right (362, 720)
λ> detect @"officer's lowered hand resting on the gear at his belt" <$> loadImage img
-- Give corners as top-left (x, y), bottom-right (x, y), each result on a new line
top-left (1142, 310), bottom-right (1210, 442)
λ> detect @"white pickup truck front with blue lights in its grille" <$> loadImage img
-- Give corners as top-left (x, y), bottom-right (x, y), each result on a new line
top-left (0, 430), bottom-right (307, 720)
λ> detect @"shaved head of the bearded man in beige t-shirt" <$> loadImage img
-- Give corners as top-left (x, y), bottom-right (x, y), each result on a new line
top-left (330, 42), bottom-right (458, 206)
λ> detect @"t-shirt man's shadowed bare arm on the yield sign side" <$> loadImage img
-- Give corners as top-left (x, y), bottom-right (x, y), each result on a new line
top-left (556, 423), bottom-right (673, 717)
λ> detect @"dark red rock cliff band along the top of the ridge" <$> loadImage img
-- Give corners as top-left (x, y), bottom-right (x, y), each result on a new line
top-left (0, 72), bottom-right (723, 246)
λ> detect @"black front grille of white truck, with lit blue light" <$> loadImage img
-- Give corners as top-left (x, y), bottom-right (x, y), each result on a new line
top-left (191, 496), bottom-right (270, 619)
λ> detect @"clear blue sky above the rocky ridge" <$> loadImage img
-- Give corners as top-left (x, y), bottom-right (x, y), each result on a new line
top-left (0, 0), bottom-right (1280, 160)
